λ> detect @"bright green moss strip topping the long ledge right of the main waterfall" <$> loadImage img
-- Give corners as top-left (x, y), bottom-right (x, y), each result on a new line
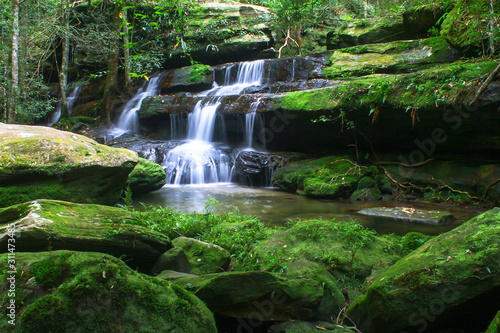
top-left (280, 61), bottom-right (497, 112)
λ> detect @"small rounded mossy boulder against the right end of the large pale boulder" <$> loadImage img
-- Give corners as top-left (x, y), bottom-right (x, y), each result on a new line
top-left (128, 158), bottom-right (167, 194)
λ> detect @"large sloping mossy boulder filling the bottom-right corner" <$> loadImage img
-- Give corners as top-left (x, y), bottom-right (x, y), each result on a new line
top-left (347, 208), bottom-right (500, 333)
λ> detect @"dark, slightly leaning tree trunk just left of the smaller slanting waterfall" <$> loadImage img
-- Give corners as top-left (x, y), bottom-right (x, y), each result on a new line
top-left (103, 3), bottom-right (125, 123)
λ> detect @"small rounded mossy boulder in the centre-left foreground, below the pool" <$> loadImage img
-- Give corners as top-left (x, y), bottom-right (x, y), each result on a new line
top-left (172, 237), bottom-right (231, 274)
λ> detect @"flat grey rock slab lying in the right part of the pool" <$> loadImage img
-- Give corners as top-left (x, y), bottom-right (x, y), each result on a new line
top-left (358, 207), bottom-right (455, 224)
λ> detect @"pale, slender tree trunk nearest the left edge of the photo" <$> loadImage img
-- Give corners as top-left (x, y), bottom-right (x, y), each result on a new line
top-left (7, 0), bottom-right (19, 124)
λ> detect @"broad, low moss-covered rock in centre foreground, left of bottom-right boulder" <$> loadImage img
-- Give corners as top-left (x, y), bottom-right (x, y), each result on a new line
top-left (252, 220), bottom-right (401, 280)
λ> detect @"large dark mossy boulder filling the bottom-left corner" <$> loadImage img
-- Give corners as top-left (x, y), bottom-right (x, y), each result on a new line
top-left (0, 250), bottom-right (217, 333)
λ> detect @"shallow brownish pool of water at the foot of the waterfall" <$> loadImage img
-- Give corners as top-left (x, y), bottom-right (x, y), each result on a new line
top-left (134, 183), bottom-right (480, 235)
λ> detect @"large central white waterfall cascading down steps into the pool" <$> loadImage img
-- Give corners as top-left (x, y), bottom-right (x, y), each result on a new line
top-left (163, 60), bottom-right (264, 185)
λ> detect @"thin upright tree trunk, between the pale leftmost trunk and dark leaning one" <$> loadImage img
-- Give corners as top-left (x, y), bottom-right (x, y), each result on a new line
top-left (59, 0), bottom-right (70, 118)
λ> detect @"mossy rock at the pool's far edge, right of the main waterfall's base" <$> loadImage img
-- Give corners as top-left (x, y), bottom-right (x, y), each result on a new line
top-left (272, 156), bottom-right (376, 198)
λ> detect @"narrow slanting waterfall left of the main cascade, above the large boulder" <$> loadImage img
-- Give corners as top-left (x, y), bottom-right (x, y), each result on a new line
top-left (109, 76), bottom-right (160, 138)
